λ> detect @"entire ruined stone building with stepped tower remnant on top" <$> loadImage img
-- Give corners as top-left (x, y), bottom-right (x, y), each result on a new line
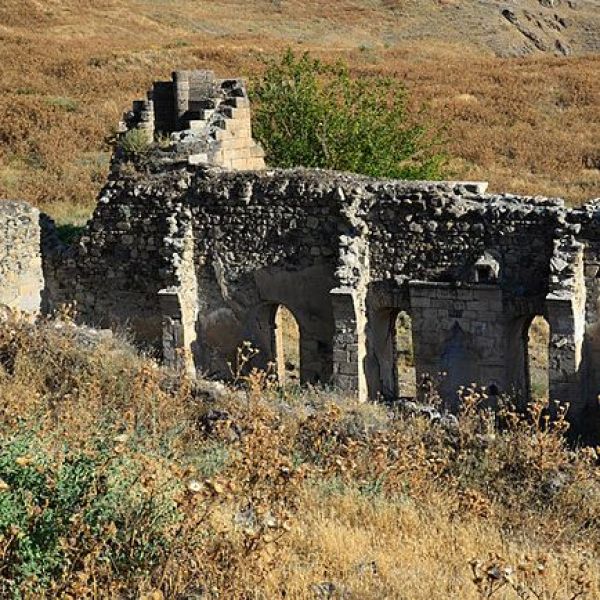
top-left (0, 72), bottom-right (600, 436)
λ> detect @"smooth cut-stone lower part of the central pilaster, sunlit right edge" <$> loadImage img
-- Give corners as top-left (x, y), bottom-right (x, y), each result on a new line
top-left (331, 288), bottom-right (367, 402)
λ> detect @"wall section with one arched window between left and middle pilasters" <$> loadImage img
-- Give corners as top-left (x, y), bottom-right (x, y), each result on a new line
top-left (189, 171), bottom-right (340, 383)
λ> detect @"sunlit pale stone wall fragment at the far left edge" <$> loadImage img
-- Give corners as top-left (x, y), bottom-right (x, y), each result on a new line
top-left (0, 200), bottom-right (44, 313)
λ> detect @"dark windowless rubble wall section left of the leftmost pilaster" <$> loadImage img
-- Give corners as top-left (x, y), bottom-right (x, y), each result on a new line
top-left (48, 171), bottom-right (196, 347)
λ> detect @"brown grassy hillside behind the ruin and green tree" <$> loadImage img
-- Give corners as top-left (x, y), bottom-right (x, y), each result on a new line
top-left (0, 0), bottom-right (600, 227)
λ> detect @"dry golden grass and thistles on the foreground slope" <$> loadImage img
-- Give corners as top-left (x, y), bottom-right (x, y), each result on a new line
top-left (0, 312), bottom-right (600, 600)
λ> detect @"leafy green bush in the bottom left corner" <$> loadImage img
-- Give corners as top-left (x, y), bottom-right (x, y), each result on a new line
top-left (0, 433), bottom-right (179, 598)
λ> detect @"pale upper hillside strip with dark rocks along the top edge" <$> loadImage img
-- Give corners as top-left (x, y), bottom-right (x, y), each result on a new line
top-left (0, 0), bottom-right (600, 57)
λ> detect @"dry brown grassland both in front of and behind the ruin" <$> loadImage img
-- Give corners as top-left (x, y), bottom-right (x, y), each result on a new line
top-left (0, 0), bottom-right (600, 600)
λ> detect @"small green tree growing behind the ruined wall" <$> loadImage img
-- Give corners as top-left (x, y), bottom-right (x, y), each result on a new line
top-left (252, 49), bottom-right (444, 179)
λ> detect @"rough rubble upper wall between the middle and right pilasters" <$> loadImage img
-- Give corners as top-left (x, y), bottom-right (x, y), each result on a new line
top-left (368, 183), bottom-right (564, 298)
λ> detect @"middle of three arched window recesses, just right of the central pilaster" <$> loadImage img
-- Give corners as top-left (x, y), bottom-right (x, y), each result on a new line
top-left (366, 309), bottom-right (416, 400)
